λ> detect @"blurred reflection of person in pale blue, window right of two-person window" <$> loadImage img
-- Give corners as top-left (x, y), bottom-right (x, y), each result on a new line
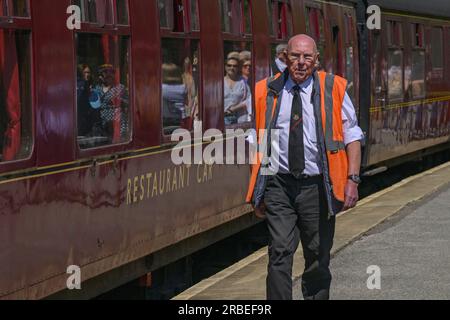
top-left (162, 63), bottom-right (188, 134)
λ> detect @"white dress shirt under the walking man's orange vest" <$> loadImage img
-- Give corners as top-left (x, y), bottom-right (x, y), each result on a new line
top-left (270, 76), bottom-right (364, 175)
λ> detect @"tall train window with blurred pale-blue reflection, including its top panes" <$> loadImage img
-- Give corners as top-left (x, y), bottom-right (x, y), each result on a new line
top-left (159, 0), bottom-right (201, 136)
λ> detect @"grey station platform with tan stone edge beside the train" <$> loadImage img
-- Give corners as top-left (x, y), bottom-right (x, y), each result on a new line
top-left (173, 163), bottom-right (450, 300)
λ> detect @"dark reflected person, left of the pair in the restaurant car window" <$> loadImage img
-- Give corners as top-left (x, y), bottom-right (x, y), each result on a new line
top-left (77, 64), bottom-right (100, 136)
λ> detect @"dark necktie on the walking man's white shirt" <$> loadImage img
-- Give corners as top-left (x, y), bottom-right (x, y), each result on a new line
top-left (289, 86), bottom-right (305, 178)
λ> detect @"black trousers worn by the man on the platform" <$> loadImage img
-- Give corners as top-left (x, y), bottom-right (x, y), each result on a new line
top-left (264, 174), bottom-right (335, 300)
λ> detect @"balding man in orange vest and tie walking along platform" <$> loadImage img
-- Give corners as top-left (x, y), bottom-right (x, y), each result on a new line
top-left (247, 35), bottom-right (364, 300)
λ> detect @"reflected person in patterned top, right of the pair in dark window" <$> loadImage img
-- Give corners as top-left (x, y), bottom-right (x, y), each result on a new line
top-left (90, 64), bottom-right (129, 138)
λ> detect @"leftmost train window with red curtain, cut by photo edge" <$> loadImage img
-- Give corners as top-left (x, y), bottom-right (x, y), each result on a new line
top-left (0, 1), bottom-right (33, 162)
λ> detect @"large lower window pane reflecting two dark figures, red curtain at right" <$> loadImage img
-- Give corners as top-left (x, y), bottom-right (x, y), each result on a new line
top-left (76, 33), bottom-right (130, 149)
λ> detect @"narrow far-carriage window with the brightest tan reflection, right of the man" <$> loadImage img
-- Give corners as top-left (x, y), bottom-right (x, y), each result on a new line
top-left (388, 49), bottom-right (403, 100)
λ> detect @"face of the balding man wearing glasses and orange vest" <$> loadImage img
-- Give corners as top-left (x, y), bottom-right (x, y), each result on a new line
top-left (287, 39), bottom-right (319, 84)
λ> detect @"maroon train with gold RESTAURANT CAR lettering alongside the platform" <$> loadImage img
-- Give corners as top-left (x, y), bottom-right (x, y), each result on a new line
top-left (0, 0), bottom-right (450, 299)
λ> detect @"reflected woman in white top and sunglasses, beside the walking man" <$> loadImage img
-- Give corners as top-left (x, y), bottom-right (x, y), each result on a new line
top-left (224, 54), bottom-right (251, 125)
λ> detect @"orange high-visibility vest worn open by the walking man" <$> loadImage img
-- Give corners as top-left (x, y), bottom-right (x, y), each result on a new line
top-left (247, 72), bottom-right (348, 206)
